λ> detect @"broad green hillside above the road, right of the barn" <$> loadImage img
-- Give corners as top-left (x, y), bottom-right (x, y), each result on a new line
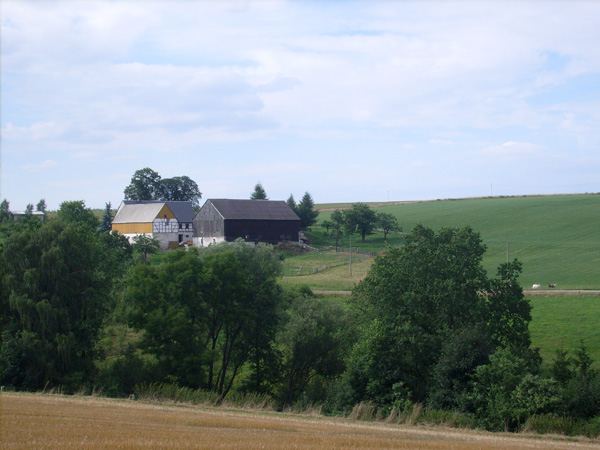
top-left (310, 194), bottom-right (600, 289)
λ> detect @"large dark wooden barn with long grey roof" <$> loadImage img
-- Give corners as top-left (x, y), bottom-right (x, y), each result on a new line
top-left (194, 199), bottom-right (300, 247)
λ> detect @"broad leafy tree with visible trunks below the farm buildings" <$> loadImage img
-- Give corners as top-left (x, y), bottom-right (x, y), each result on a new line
top-left (127, 242), bottom-right (281, 397)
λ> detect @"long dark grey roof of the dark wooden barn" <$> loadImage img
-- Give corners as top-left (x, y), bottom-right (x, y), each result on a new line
top-left (205, 198), bottom-right (300, 220)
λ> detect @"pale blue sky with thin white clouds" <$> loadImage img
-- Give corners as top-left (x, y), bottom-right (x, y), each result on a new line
top-left (0, 0), bottom-right (600, 211)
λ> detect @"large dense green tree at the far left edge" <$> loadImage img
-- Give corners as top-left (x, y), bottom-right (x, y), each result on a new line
top-left (0, 220), bottom-right (110, 390)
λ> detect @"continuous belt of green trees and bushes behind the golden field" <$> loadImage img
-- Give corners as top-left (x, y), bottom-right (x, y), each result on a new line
top-left (0, 197), bottom-right (600, 433)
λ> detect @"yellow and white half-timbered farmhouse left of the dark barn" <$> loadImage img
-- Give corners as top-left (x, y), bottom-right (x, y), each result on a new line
top-left (112, 200), bottom-right (194, 248)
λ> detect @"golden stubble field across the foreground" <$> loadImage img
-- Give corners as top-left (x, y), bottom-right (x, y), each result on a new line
top-left (0, 393), bottom-right (600, 450)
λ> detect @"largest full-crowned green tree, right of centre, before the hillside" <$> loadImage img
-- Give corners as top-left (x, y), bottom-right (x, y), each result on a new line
top-left (352, 225), bottom-right (530, 403)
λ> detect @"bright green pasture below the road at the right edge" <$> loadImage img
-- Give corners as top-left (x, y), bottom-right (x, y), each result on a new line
top-left (529, 296), bottom-right (600, 367)
